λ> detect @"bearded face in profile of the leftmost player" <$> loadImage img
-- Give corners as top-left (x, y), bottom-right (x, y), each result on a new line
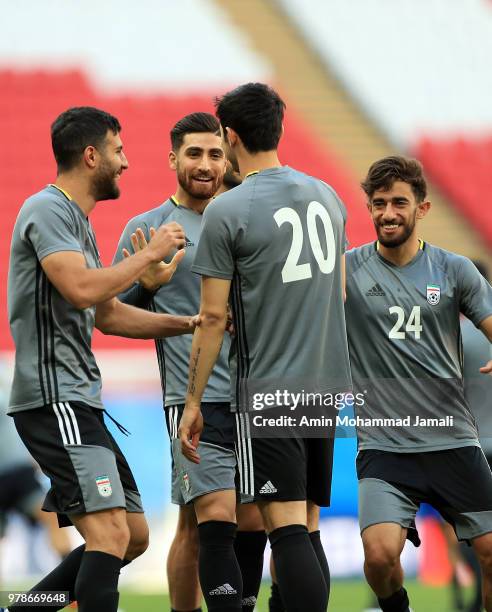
top-left (92, 130), bottom-right (128, 202)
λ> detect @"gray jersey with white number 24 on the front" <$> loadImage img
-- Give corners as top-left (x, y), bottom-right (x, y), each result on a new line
top-left (346, 243), bottom-right (492, 452)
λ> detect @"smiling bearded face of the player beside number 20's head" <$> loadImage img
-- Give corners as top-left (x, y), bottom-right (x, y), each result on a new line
top-left (169, 132), bottom-right (226, 200)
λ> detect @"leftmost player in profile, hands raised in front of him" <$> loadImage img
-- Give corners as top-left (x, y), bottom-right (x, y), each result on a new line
top-left (8, 107), bottom-right (195, 612)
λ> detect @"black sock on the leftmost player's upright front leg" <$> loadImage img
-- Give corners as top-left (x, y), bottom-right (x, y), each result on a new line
top-left (75, 550), bottom-right (122, 612)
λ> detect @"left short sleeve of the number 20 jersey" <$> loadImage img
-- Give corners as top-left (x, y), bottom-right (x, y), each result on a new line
top-left (191, 201), bottom-right (238, 280)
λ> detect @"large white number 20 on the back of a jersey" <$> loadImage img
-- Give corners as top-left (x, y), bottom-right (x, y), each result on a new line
top-left (273, 201), bottom-right (336, 283)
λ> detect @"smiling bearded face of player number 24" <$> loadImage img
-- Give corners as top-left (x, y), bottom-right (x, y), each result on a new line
top-left (368, 181), bottom-right (427, 248)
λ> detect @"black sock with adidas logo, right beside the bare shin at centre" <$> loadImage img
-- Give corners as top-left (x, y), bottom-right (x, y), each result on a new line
top-left (198, 521), bottom-right (243, 612)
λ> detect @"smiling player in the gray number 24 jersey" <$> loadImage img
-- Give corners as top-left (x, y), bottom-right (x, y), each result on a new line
top-left (346, 157), bottom-right (492, 612)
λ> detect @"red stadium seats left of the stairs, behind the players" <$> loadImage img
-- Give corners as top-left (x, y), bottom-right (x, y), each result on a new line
top-left (0, 70), bottom-right (371, 349)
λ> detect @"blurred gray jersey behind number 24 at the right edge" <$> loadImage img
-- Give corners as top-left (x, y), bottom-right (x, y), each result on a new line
top-left (461, 319), bottom-right (492, 456)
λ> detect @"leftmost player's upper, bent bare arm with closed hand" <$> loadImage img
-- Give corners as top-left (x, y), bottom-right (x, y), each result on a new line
top-left (41, 223), bottom-right (185, 309)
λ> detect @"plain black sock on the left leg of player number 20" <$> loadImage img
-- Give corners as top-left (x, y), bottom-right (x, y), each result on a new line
top-left (269, 525), bottom-right (328, 612)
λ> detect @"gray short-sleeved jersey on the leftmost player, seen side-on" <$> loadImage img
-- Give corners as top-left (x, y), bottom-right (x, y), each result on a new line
top-left (8, 185), bottom-right (103, 414)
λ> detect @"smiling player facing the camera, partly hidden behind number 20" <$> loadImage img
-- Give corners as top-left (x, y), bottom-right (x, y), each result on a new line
top-left (114, 112), bottom-right (266, 611)
